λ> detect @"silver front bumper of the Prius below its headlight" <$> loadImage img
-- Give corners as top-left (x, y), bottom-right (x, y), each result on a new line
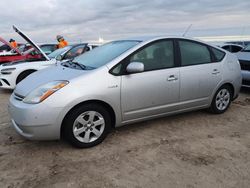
top-left (9, 94), bottom-right (62, 140)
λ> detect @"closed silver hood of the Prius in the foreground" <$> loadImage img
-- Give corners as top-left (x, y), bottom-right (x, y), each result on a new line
top-left (14, 65), bottom-right (89, 96)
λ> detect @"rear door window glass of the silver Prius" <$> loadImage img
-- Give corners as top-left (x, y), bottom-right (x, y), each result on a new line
top-left (179, 40), bottom-right (211, 66)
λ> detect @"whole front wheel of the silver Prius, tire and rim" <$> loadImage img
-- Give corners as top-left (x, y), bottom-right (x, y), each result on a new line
top-left (62, 104), bottom-right (111, 148)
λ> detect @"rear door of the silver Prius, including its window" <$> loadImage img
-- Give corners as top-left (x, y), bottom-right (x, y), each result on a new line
top-left (178, 39), bottom-right (222, 109)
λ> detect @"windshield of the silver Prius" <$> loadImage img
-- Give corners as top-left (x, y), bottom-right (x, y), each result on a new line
top-left (73, 40), bottom-right (140, 68)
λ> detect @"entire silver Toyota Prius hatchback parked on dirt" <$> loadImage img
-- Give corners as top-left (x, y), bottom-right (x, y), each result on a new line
top-left (9, 37), bottom-right (242, 148)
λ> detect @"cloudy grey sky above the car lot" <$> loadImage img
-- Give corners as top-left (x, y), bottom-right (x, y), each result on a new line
top-left (0, 0), bottom-right (250, 42)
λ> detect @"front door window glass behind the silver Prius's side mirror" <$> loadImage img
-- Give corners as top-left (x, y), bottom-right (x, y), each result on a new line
top-left (129, 40), bottom-right (174, 71)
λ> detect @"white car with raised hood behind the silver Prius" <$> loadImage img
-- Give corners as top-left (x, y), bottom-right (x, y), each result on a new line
top-left (0, 25), bottom-right (92, 89)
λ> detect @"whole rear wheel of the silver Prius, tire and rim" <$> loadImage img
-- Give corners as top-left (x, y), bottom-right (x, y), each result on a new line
top-left (209, 85), bottom-right (233, 114)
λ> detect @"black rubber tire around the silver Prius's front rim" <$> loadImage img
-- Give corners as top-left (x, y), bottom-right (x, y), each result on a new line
top-left (63, 104), bottom-right (111, 148)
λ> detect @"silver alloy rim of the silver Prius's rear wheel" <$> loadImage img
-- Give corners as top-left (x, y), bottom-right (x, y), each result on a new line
top-left (215, 89), bottom-right (230, 110)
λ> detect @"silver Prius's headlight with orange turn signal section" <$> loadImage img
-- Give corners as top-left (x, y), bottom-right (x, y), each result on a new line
top-left (23, 81), bottom-right (69, 104)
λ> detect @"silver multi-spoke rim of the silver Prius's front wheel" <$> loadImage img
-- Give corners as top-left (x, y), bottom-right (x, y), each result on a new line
top-left (73, 111), bottom-right (105, 143)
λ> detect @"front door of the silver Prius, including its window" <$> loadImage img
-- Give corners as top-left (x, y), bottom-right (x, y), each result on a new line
top-left (121, 40), bottom-right (180, 121)
